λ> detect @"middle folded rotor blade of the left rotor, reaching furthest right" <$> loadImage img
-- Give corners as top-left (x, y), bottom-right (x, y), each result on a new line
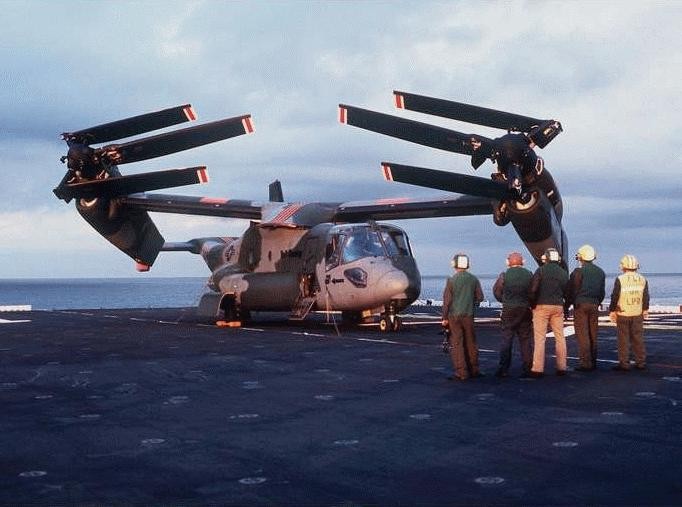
top-left (99, 114), bottom-right (254, 164)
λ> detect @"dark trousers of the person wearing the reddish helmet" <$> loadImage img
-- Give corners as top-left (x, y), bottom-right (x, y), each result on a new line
top-left (499, 306), bottom-right (533, 373)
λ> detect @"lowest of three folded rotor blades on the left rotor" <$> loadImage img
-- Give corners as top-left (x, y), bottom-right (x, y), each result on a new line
top-left (54, 167), bottom-right (208, 200)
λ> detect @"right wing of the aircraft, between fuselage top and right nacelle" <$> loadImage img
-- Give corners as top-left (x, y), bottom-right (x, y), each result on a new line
top-left (333, 194), bottom-right (494, 222)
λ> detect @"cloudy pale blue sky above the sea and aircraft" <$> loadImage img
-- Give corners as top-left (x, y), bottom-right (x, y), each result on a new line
top-left (0, 0), bottom-right (682, 278)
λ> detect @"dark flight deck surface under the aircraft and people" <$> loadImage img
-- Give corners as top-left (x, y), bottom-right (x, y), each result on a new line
top-left (0, 307), bottom-right (682, 506)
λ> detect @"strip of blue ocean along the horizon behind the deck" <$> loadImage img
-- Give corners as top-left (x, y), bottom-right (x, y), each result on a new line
top-left (0, 273), bottom-right (682, 310)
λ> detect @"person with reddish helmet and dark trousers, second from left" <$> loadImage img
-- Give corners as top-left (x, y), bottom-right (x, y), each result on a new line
top-left (493, 252), bottom-right (533, 377)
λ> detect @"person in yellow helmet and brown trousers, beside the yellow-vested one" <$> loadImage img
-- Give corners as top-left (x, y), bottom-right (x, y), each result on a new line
top-left (566, 245), bottom-right (606, 371)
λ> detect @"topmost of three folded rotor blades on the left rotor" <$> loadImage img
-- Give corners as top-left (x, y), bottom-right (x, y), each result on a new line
top-left (62, 104), bottom-right (196, 144)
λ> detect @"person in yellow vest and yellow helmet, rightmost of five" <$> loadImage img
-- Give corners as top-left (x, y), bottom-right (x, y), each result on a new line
top-left (609, 255), bottom-right (649, 371)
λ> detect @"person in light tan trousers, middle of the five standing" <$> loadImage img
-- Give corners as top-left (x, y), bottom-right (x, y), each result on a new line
top-left (529, 248), bottom-right (568, 378)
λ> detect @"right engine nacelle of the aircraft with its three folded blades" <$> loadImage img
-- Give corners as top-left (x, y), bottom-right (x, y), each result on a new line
top-left (339, 91), bottom-right (568, 263)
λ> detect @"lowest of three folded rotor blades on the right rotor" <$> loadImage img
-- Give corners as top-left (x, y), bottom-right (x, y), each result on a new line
top-left (381, 162), bottom-right (509, 199)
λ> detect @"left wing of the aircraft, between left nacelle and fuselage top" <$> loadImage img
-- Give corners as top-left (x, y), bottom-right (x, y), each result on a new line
top-left (120, 193), bottom-right (263, 220)
